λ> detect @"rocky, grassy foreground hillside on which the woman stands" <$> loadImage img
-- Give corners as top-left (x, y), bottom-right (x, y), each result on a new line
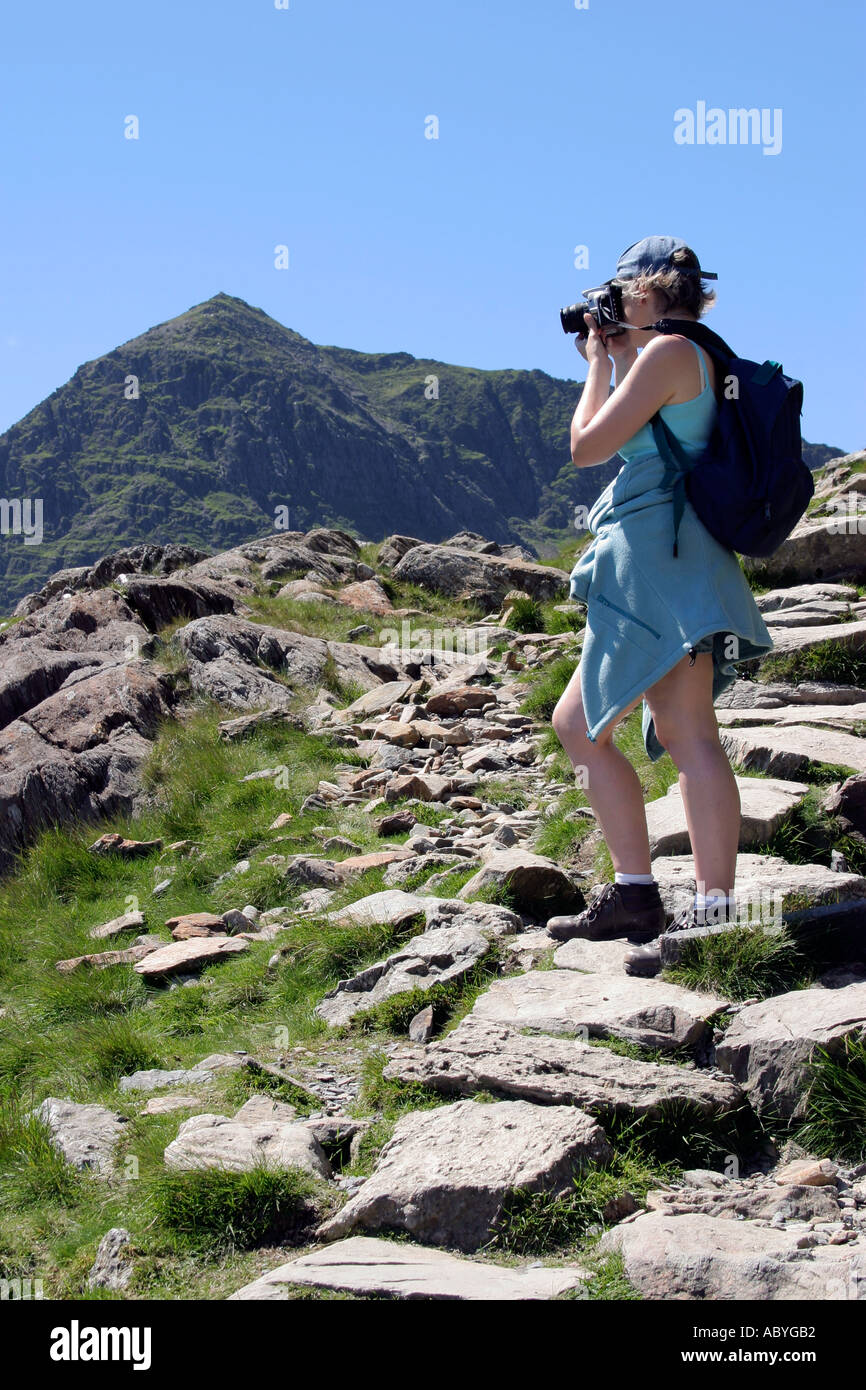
top-left (0, 455), bottom-right (866, 1301)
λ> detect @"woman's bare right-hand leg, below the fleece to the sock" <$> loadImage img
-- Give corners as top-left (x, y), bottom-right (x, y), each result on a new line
top-left (646, 652), bottom-right (741, 894)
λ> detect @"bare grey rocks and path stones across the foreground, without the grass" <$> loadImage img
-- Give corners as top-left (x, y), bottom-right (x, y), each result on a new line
top-left (6, 460), bottom-right (866, 1300)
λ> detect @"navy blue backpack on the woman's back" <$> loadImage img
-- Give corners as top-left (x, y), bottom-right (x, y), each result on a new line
top-left (651, 318), bottom-right (815, 557)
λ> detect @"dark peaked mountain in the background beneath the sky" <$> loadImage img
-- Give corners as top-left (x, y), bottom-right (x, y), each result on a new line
top-left (0, 293), bottom-right (841, 607)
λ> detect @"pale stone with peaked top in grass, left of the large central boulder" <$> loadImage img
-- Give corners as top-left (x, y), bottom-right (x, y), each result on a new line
top-left (164, 1095), bottom-right (332, 1177)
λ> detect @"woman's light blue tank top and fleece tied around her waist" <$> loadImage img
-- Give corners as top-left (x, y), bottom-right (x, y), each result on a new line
top-left (569, 343), bottom-right (773, 762)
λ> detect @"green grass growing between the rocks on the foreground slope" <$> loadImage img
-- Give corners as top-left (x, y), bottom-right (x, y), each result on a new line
top-left (0, 492), bottom-right (863, 1298)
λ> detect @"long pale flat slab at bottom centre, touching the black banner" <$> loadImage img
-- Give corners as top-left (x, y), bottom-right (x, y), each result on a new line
top-left (229, 1236), bottom-right (588, 1302)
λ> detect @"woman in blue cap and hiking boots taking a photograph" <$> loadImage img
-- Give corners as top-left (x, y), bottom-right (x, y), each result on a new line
top-left (548, 236), bottom-right (773, 974)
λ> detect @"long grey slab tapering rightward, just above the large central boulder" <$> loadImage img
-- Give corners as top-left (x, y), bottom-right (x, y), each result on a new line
top-left (382, 1015), bottom-right (744, 1116)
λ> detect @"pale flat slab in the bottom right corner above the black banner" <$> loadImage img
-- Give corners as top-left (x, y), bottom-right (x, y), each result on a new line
top-left (598, 1212), bottom-right (866, 1302)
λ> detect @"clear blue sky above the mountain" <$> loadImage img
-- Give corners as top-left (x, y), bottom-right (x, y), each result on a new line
top-left (0, 0), bottom-right (866, 449)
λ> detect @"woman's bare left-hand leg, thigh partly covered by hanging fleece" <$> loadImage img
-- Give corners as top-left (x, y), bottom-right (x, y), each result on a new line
top-left (552, 666), bottom-right (652, 873)
